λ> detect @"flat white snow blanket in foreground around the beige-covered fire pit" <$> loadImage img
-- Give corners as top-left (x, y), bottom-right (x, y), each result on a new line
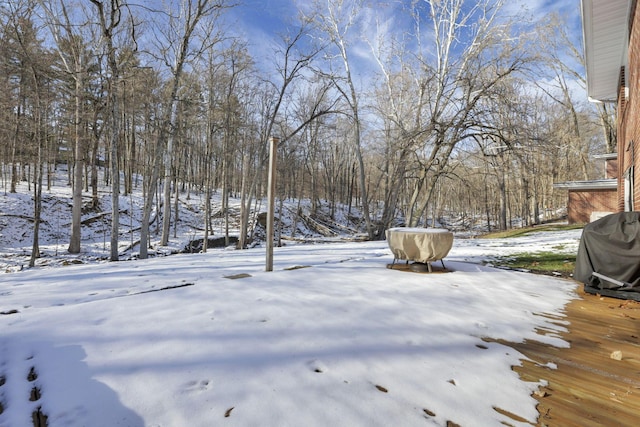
top-left (0, 231), bottom-right (580, 427)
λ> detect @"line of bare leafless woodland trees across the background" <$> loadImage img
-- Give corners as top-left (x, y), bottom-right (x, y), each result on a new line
top-left (0, 0), bottom-right (615, 264)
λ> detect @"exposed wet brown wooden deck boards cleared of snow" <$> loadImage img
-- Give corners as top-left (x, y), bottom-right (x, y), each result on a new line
top-left (504, 287), bottom-right (640, 427)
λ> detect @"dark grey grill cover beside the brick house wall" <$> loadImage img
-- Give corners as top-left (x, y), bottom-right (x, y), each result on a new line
top-left (573, 212), bottom-right (640, 292)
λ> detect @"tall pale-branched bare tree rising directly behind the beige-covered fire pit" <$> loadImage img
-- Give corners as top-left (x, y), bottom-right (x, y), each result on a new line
top-left (384, 0), bottom-right (535, 226)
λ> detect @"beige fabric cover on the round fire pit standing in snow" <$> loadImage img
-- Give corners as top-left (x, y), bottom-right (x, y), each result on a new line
top-left (386, 227), bottom-right (453, 263)
